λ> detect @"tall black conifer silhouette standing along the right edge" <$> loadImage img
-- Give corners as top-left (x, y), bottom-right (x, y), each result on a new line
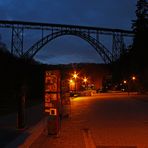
top-left (130, 0), bottom-right (148, 88)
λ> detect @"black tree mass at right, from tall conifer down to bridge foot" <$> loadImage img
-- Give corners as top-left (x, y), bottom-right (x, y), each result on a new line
top-left (113, 0), bottom-right (148, 88)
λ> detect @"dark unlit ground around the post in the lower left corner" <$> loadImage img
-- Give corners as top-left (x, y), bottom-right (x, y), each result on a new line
top-left (0, 105), bottom-right (43, 148)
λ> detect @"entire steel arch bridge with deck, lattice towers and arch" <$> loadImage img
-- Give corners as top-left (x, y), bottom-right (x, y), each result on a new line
top-left (0, 20), bottom-right (134, 63)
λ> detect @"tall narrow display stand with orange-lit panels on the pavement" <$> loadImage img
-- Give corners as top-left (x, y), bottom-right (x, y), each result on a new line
top-left (44, 70), bottom-right (61, 134)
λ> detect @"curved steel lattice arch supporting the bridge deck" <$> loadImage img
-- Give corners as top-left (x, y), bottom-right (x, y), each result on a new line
top-left (22, 30), bottom-right (113, 63)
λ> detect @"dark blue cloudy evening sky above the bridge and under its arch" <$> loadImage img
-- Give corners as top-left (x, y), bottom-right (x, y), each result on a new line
top-left (0, 0), bottom-right (136, 64)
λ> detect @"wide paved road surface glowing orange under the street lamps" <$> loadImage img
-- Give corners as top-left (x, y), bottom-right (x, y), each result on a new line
top-left (31, 93), bottom-right (148, 148)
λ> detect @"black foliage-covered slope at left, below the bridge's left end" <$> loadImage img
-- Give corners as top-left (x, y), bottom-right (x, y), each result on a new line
top-left (0, 46), bottom-right (44, 113)
